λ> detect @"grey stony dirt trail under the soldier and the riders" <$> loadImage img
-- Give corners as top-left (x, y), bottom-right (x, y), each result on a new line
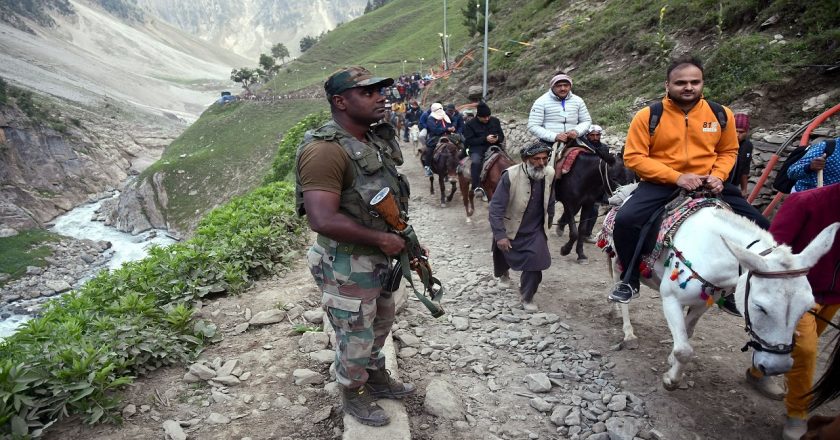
top-left (47, 143), bottom-right (840, 439)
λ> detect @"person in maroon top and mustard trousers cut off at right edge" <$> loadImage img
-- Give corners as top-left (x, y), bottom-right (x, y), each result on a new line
top-left (747, 183), bottom-right (840, 439)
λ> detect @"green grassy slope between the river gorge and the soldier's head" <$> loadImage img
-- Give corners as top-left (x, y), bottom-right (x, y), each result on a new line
top-left (140, 100), bottom-right (327, 231)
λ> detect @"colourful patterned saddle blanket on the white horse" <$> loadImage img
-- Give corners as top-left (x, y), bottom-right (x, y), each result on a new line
top-left (596, 196), bottom-right (731, 278)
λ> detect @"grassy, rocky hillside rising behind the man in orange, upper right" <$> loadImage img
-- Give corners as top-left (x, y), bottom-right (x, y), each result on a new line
top-left (433, 0), bottom-right (840, 130)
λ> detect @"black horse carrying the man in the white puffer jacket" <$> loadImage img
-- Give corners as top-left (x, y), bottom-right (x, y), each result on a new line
top-left (554, 149), bottom-right (635, 263)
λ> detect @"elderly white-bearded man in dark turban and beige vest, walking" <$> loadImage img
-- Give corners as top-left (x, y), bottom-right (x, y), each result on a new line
top-left (489, 141), bottom-right (554, 312)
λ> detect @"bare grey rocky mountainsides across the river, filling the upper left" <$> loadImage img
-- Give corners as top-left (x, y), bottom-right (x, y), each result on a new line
top-left (0, 0), bottom-right (365, 231)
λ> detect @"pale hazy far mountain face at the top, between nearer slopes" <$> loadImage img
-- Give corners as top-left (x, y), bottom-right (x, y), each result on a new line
top-left (137, 0), bottom-right (367, 60)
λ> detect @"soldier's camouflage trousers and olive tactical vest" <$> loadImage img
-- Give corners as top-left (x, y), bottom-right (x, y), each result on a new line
top-left (296, 121), bottom-right (409, 388)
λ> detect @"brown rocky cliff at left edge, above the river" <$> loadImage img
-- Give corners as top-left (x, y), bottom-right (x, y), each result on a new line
top-left (0, 100), bottom-right (180, 229)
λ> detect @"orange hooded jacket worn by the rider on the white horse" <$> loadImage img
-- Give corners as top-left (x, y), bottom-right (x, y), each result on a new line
top-left (624, 96), bottom-right (738, 185)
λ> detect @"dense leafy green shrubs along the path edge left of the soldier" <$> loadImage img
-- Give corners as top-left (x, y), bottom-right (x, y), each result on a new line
top-left (0, 182), bottom-right (304, 438)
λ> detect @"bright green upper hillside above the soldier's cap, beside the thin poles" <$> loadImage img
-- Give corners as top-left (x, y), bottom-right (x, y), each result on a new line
top-left (269, 0), bottom-right (469, 91)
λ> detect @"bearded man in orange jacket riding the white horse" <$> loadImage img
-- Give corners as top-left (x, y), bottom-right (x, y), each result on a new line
top-left (609, 58), bottom-right (770, 303)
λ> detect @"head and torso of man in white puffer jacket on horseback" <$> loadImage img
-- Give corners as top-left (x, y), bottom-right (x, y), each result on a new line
top-left (528, 73), bottom-right (592, 143)
